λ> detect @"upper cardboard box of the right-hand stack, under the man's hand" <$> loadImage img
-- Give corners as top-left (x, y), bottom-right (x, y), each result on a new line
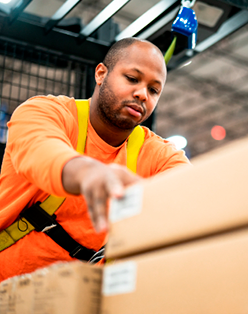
top-left (106, 138), bottom-right (248, 259)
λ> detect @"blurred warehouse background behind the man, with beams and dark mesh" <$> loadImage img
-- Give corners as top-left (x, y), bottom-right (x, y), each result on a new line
top-left (0, 0), bottom-right (248, 162)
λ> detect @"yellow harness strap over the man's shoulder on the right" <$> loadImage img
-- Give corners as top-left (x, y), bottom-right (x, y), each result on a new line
top-left (127, 125), bottom-right (145, 173)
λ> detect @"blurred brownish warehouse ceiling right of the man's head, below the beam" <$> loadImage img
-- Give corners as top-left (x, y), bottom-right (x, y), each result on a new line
top-left (156, 25), bottom-right (248, 157)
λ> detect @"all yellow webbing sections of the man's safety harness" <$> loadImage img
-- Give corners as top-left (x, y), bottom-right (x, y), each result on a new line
top-left (0, 100), bottom-right (145, 251)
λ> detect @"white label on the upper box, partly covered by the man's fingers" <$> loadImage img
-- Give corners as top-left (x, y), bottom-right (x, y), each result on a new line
top-left (109, 184), bottom-right (143, 222)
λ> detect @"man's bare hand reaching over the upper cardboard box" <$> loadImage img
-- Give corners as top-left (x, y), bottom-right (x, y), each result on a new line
top-left (62, 156), bottom-right (141, 232)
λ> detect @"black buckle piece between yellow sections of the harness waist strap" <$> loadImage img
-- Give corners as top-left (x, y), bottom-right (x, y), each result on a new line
top-left (20, 202), bottom-right (57, 231)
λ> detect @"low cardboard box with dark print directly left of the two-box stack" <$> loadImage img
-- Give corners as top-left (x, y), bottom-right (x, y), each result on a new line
top-left (33, 262), bottom-right (102, 314)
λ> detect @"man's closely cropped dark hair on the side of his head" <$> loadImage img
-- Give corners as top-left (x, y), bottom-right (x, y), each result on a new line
top-left (103, 37), bottom-right (146, 72)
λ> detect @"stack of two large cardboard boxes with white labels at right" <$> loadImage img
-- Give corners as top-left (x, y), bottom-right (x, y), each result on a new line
top-left (101, 139), bottom-right (248, 314)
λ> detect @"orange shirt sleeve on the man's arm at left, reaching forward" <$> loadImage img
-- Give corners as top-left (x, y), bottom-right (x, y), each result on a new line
top-left (8, 96), bottom-right (79, 196)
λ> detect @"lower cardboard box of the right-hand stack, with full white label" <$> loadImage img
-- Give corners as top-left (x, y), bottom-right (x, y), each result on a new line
top-left (101, 229), bottom-right (248, 314)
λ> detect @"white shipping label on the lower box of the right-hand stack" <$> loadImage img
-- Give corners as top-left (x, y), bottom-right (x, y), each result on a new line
top-left (102, 262), bottom-right (137, 296)
